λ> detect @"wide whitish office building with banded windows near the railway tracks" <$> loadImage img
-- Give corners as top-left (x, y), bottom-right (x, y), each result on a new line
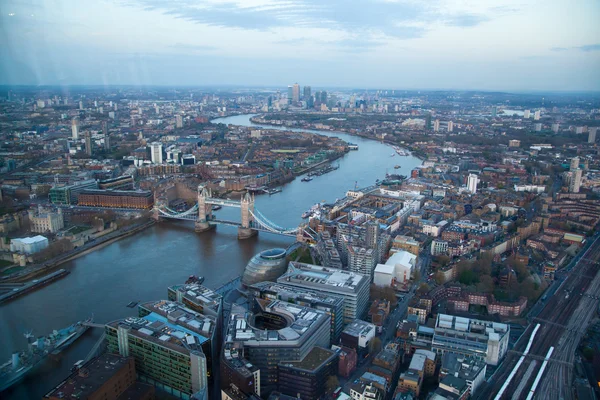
top-left (431, 313), bottom-right (510, 365)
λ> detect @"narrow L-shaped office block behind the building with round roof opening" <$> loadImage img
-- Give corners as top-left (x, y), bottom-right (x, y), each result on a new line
top-left (248, 282), bottom-right (344, 343)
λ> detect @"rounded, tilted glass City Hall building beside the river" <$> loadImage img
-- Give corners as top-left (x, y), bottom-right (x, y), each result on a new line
top-left (242, 248), bottom-right (287, 287)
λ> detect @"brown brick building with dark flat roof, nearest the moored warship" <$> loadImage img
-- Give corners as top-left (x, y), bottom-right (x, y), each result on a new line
top-left (42, 353), bottom-right (154, 400)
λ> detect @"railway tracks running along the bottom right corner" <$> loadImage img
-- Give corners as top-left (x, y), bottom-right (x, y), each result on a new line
top-left (477, 234), bottom-right (600, 400)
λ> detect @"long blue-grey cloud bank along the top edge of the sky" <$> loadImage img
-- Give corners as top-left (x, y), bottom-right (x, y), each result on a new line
top-left (120, 0), bottom-right (498, 39)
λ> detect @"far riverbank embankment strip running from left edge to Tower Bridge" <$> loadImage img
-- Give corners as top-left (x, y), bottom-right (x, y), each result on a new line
top-left (2, 220), bottom-right (156, 283)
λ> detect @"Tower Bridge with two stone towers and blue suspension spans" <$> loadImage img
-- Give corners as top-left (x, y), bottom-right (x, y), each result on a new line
top-left (154, 185), bottom-right (315, 241)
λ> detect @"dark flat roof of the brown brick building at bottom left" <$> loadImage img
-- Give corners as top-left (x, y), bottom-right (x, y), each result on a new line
top-left (44, 353), bottom-right (135, 399)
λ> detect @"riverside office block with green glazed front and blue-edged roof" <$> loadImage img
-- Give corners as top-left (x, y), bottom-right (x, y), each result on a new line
top-left (106, 300), bottom-right (215, 399)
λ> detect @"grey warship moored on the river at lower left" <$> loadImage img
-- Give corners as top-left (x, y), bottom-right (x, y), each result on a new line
top-left (0, 318), bottom-right (92, 392)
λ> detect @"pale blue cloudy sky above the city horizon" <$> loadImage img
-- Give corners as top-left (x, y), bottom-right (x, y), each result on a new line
top-left (0, 0), bottom-right (600, 91)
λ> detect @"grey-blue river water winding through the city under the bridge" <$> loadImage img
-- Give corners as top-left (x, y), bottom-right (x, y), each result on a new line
top-left (0, 115), bottom-right (421, 399)
